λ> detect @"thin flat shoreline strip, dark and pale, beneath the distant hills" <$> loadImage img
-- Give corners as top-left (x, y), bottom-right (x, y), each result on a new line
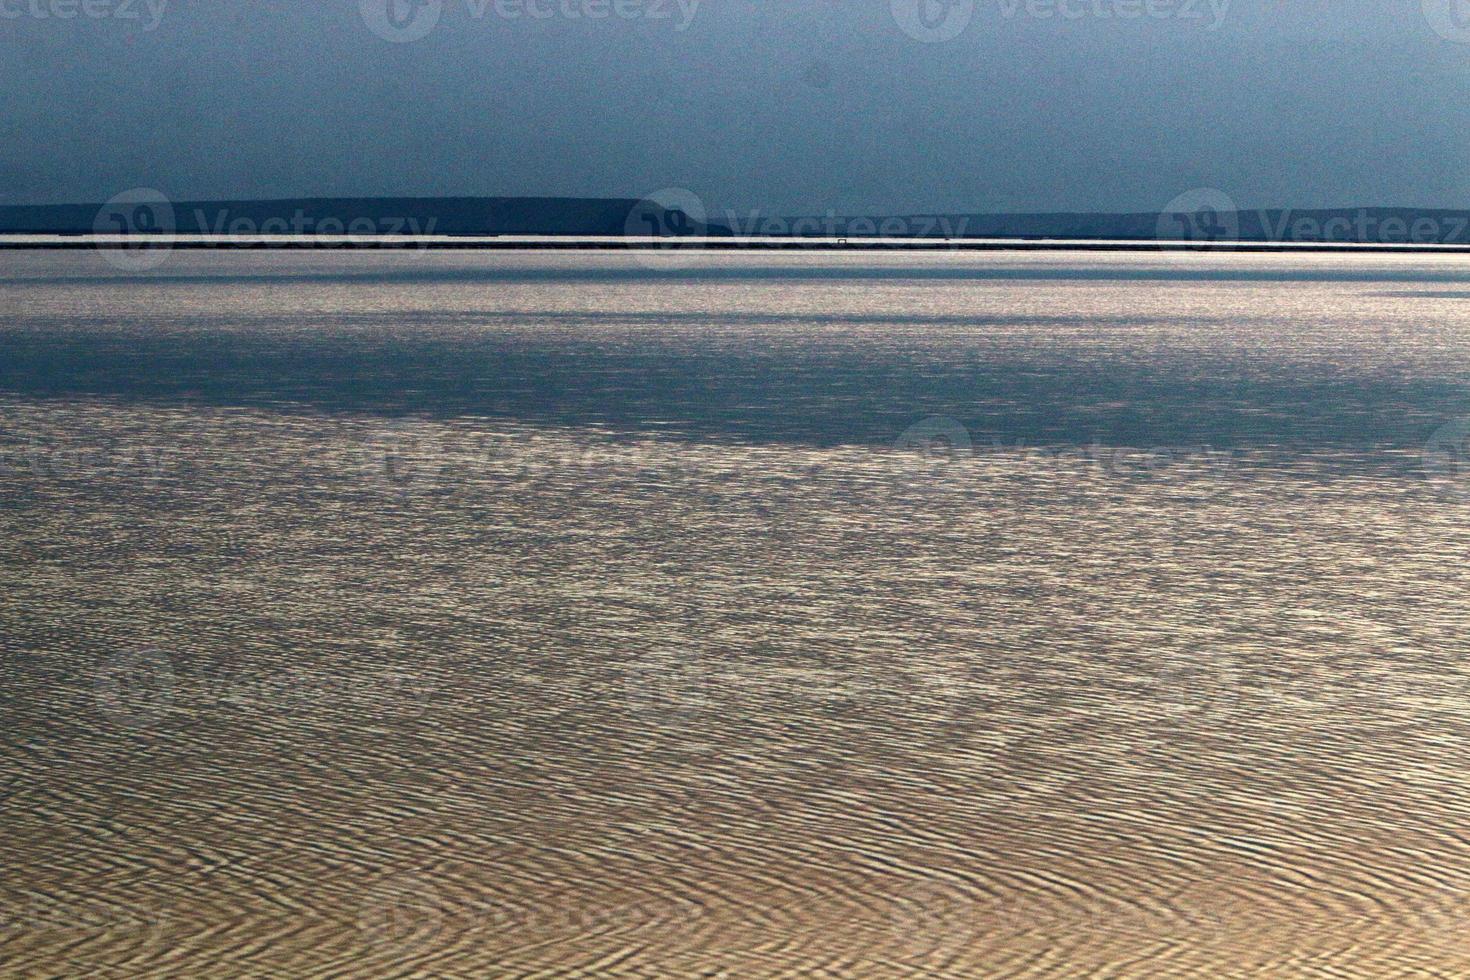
top-left (0, 234), bottom-right (1470, 254)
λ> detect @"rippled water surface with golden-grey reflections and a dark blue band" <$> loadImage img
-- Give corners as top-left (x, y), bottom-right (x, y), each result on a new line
top-left (0, 253), bottom-right (1470, 977)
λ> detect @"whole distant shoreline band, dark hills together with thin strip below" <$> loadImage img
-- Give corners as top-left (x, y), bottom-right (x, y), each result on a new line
top-left (11, 198), bottom-right (1470, 253)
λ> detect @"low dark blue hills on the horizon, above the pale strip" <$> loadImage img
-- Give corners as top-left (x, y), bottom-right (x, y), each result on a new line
top-left (0, 197), bottom-right (1470, 244)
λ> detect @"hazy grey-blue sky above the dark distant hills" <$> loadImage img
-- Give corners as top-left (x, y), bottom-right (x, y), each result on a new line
top-left (0, 0), bottom-right (1470, 212)
